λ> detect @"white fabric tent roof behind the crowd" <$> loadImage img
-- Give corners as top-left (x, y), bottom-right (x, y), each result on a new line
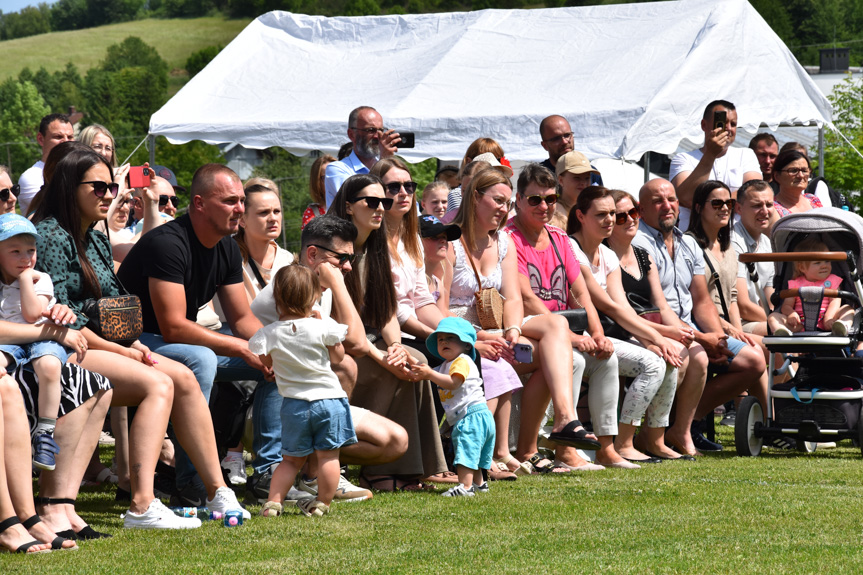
top-left (150, 0), bottom-right (832, 161)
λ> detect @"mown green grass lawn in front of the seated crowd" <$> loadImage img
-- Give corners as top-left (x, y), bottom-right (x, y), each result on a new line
top-left (0, 420), bottom-right (863, 574)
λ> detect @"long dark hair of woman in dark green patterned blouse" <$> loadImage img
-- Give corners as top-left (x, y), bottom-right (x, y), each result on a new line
top-left (33, 142), bottom-right (114, 298)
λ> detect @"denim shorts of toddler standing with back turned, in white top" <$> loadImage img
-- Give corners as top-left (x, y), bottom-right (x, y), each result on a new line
top-left (281, 397), bottom-right (357, 457)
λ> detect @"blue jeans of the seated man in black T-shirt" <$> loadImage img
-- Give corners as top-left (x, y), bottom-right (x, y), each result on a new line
top-left (138, 333), bottom-right (282, 489)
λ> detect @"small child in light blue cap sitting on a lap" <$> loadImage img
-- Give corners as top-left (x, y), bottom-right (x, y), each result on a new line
top-left (0, 214), bottom-right (86, 471)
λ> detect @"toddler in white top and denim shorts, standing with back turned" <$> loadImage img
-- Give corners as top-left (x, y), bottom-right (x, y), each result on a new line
top-left (249, 264), bottom-right (357, 517)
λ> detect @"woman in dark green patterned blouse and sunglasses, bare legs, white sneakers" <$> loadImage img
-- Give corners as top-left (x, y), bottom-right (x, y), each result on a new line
top-left (33, 145), bottom-right (239, 529)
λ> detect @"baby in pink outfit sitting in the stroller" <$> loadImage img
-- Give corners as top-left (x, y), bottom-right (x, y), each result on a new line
top-left (767, 238), bottom-right (854, 336)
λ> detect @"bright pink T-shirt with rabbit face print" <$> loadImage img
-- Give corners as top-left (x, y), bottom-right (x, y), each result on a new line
top-left (506, 223), bottom-right (580, 311)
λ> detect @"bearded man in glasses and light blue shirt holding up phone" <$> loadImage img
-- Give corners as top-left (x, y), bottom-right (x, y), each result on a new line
top-left (324, 106), bottom-right (402, 209)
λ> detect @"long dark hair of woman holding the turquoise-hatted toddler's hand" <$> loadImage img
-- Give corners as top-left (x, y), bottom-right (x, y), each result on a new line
top-left (327, 174), bottom-right (396, 329)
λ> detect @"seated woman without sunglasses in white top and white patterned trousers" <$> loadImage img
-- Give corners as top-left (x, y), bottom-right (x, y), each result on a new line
top-left (566, 186), bottom-right (688, 465)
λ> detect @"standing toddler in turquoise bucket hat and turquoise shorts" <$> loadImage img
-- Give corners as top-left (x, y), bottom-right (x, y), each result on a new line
top-left (411, 317), bottom-right (495, 497)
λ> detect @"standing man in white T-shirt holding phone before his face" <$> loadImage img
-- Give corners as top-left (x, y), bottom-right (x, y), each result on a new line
top-left (668, 100), bottom-right (761, 230)
